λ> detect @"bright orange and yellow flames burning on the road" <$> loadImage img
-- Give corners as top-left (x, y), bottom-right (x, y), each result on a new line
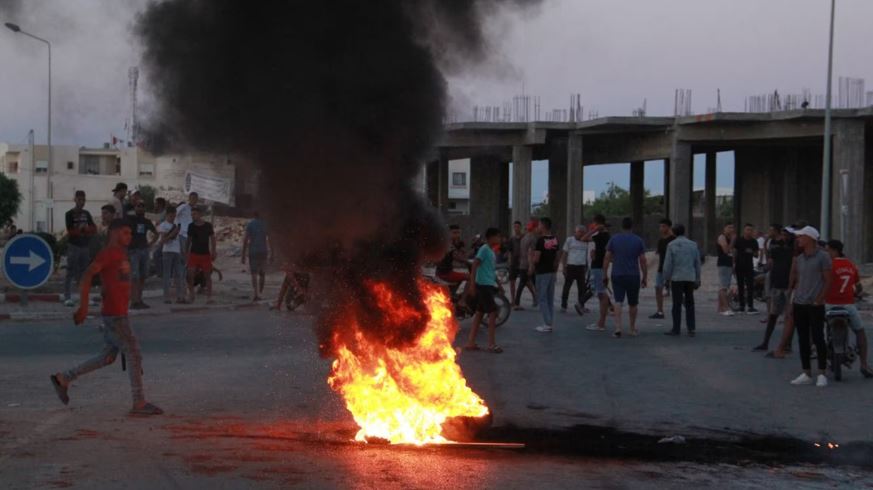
top-left (328, 280), bottom-right (488, 445)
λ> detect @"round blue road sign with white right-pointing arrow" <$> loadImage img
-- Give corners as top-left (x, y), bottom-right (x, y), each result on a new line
top-left (3, 235), bottom-right (55, 289)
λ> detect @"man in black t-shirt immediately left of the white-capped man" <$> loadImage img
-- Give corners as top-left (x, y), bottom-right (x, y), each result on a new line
top-left (752, 228), bottom-right (794, 352)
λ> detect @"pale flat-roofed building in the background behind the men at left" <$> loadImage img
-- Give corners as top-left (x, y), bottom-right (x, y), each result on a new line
top-left (0, 143), bottom-right (237, 233)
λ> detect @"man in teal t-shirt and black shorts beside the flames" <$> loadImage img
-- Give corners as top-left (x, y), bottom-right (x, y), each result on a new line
top-left (464, 228), bottom-right (503, 354)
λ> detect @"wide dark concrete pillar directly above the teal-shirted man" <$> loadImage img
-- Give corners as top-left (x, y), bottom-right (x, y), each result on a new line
top-left (468, 157), bottom-right (503, 236)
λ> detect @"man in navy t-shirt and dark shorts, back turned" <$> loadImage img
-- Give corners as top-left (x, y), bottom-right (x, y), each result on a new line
top-left (603, 218), bottom-right (649, 338)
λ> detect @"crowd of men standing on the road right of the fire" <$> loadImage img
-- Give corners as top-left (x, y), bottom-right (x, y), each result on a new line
top-left (436, 215), bottom-right (873, 387)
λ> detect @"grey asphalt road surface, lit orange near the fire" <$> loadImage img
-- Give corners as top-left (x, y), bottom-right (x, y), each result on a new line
top-left (0, 288), bottom-right (873, 489)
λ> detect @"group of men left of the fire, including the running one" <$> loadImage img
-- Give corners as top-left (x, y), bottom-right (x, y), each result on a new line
top-left (50, 183), bottom-right (269, 416)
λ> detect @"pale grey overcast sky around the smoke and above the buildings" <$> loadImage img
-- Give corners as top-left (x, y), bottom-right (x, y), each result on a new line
top-left (0, 0), bottom-right (873, 196)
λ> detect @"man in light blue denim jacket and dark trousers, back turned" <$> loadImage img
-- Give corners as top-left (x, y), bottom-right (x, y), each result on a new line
top-left (663, 224), bottom-right (700, 337)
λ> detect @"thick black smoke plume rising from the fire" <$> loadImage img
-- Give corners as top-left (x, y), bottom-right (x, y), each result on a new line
top-left (136, 0), bottom-right (529, 350)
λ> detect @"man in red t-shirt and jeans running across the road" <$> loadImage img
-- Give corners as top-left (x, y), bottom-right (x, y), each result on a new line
top-left (51, 219), bottom-right (164, 415)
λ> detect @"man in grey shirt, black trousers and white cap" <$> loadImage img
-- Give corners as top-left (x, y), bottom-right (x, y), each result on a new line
top-left (788, 226), bottom-right (832, 388)
